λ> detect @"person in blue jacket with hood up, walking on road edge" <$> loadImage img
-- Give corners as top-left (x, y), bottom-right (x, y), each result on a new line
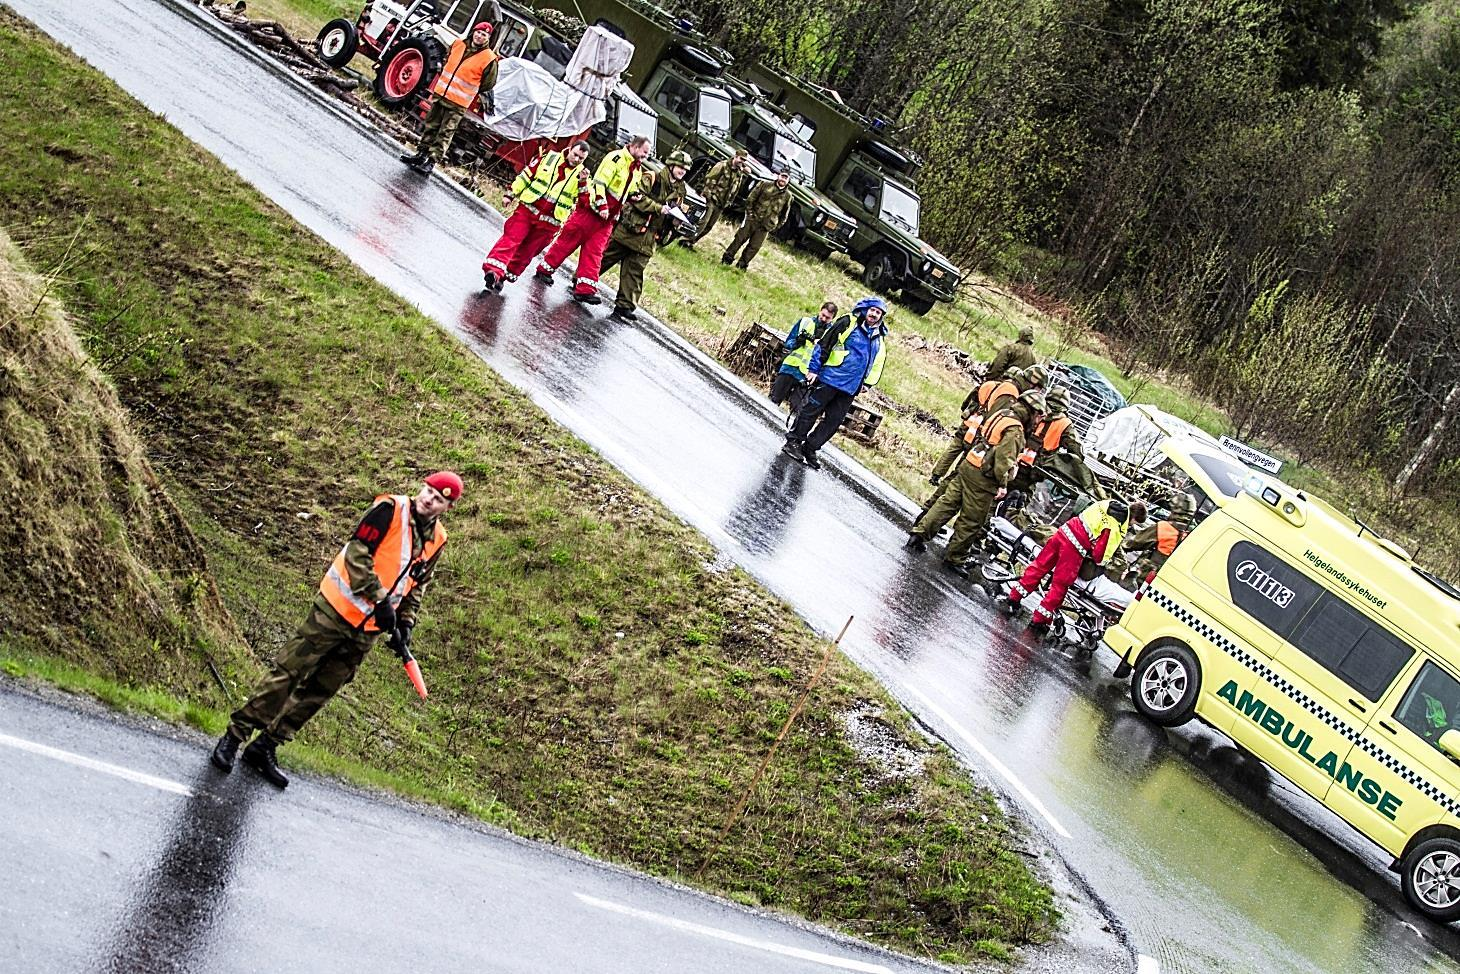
top-left (781, 298), bottom-right (888, 470)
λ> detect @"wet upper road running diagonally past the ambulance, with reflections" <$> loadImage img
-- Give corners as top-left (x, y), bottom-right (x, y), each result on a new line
top-left (7, 0), bottom-right (1460, 971)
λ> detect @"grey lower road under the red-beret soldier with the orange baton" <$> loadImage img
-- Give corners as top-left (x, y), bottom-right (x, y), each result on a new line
top-left (0, 682), bottom-right (929, 974)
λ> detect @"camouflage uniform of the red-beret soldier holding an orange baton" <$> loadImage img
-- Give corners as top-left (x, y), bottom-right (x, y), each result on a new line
top-left (228, 499), bottom-right (435, 743)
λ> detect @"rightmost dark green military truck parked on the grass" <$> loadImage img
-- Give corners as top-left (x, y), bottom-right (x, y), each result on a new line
top-left (743, 66), bottom-right (962, 314)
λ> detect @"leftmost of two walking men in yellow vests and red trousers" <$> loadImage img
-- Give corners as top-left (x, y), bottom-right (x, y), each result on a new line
top-left (482, 142), bottom-right (588, 291)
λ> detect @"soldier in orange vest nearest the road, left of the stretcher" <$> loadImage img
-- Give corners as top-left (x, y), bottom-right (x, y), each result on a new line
top-left (907, 388), bottom-right (1044, 574)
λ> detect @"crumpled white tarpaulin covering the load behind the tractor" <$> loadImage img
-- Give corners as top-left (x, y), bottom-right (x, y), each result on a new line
top-left (483, 26), bottom-right (634, 142)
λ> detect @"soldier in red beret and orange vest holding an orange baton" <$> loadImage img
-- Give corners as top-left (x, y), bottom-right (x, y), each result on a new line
top-left (212, 470), bottom-right (461, 789)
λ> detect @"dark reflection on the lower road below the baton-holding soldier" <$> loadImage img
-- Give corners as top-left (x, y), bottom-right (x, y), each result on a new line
top-left (101, 767), bottom-right (261, 974)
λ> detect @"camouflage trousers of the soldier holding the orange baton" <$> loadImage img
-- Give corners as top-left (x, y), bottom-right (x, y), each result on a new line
top-left (228, 605), bottom-right (380, 743)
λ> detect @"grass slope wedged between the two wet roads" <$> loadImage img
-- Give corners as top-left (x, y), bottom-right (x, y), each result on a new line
top-left (0, 12), bottom-right (1054, 959)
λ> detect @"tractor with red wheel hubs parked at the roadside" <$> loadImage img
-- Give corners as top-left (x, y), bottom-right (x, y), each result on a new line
top-left (315, 0), bottom-right (520, 107)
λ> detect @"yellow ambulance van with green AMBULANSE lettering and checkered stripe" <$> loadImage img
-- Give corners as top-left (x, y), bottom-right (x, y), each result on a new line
top-left (1104, 447), bottom-right (1460, 923)
